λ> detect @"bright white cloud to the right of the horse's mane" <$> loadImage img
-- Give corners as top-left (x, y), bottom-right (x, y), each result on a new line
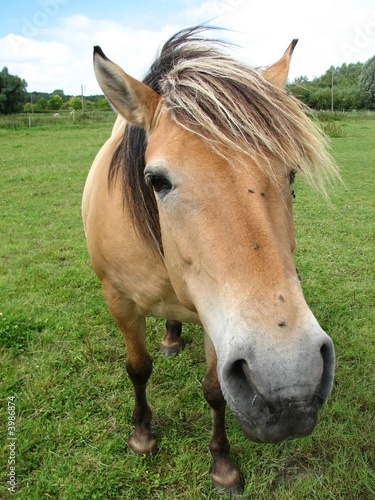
top-left (178, 0), bottom-right (375, 78)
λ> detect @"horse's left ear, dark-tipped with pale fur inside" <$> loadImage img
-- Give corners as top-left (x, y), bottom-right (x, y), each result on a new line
top-left (94, 46), bottom-right (160, 130)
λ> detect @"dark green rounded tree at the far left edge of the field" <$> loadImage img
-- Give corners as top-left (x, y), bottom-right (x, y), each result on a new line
top-left (0, 67), bottom-right (27, 115)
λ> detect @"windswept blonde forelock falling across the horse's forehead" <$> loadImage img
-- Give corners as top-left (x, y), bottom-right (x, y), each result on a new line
top-left (160, 32), bottom-right (337, 193)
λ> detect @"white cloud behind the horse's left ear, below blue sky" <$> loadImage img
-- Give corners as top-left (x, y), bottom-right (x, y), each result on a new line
top-left (0, 15), bottom-right (178, 95)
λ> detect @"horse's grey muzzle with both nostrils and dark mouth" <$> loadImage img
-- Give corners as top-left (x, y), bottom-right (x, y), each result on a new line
top-left (218, 336), bottom-right (335, 443)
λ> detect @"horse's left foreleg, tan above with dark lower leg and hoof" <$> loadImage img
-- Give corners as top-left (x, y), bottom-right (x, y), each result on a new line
top-left (103, 285), bottom-right (156, 454)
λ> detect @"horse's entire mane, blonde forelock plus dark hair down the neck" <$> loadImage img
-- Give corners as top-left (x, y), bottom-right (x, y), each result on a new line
top-left (109, 26), bottom-right (338, 253)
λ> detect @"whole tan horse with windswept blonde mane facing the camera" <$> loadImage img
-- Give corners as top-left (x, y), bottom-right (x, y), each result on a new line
top-left (82, 26), bottom-right (336, 496)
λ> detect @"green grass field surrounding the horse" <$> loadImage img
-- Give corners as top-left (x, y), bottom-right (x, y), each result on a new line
top-left (0, 111), bottom-right (375, 500)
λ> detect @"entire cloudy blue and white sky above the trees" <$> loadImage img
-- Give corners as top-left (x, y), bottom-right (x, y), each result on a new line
top-left (0, 0), bottom-right (375, 95)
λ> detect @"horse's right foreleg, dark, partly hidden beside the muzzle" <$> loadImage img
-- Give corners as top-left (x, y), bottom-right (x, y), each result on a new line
top-left (202, 333), bottom-right (243, 497)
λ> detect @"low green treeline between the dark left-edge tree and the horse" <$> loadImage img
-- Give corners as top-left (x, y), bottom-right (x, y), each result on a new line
top-left (23, 89), bottom-right (110, 113)
